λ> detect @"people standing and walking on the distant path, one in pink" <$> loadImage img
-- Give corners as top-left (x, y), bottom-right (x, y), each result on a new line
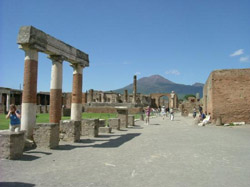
top-left (145, 106), bottom-right (174, 125)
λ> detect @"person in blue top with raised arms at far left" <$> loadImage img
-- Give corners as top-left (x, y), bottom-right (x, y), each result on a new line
top-left (6, 104), bottom-right (21, 132)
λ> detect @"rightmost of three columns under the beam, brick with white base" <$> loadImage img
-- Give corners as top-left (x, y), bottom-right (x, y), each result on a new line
top-left (71, 65), bottom-right (83, 121)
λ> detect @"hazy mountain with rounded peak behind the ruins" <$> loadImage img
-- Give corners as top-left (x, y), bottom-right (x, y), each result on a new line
top-left (113, 75), bottom-right (204, 97)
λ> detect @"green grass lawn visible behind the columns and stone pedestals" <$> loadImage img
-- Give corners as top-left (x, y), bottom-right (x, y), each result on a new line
top-left (0, 113), bottom-right (140, 130)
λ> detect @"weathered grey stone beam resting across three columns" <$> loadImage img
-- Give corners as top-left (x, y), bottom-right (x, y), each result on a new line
top-left (17, 26), bottom-right (89, 66)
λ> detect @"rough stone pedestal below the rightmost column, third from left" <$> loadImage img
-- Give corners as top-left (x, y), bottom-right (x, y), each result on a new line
top-left (60, 120), bottom-right (81, 142)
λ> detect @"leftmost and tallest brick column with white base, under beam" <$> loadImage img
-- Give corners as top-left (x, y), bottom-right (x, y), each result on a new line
top-left (21, 47), bottom-right (38, 139)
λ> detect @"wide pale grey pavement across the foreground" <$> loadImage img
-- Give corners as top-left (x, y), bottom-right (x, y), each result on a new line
top-left (0, 114), bottom-right (250, 187)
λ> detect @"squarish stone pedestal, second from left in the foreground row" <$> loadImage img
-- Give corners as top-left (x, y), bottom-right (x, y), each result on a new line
top-left (33, 123), bottom-right (59, 149)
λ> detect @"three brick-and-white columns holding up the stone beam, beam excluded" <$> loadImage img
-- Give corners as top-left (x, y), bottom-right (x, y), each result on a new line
top-left (21, 46), bottom-right (83, 139)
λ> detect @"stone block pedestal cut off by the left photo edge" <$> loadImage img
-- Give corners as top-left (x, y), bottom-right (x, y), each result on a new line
top-left (0, 130), bottom-right (25, 160)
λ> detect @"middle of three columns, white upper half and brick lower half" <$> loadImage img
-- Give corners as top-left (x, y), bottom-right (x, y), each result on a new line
top-left (49, 55), bottom-right (63, 123)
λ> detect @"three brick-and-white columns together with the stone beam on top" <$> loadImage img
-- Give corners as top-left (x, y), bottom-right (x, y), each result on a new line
top-left (17, 26), bottom-right (89, 138)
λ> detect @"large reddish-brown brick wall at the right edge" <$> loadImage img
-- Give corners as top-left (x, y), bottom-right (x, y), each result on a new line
top-left (203, 69), bottom-right (250, 123)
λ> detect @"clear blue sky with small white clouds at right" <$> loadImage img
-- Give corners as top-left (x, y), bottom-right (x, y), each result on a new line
top-left (0, 0), bottom-right (250, 92)
